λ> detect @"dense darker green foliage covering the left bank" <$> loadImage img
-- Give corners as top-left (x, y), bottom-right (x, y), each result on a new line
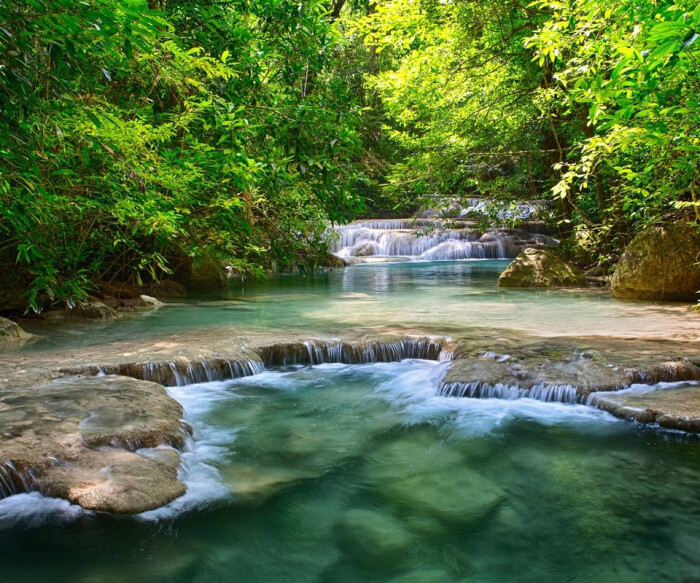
top-left (0, 0), bottom-right (370, 310)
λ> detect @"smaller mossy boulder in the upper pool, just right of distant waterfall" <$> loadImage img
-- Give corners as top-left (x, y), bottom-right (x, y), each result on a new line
top-left (498, 249), bottom-right (588, 287)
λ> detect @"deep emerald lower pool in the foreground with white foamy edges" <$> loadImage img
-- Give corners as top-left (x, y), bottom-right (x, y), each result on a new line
top-left (0, 362), bottom-right (700, 583)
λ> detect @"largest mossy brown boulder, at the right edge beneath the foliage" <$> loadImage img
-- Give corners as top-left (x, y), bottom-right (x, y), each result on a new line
top-left (612, 223), bottom-right (700, 301)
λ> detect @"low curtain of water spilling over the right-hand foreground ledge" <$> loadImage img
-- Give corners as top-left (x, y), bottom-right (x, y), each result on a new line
top-left (438, 382), bottom-right (586, 404)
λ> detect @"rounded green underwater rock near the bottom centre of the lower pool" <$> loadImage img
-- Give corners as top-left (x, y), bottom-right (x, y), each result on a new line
top-left (339, 508), bottom-right (412, 569)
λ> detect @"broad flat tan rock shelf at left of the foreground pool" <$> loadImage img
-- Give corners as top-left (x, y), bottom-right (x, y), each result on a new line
top-left (0, 377), bottom-right (186, 514)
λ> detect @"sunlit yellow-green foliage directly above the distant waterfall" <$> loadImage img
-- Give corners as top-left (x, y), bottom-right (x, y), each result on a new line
top-left (358, 0), bottom-right (548, 214)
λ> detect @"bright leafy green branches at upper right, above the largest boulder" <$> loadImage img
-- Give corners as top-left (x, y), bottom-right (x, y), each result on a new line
top-left (528, 0), bottom-right (700, 253)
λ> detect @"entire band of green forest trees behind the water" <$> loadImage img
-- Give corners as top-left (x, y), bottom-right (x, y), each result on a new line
top-left (0, 0), bottom-right (700, 310)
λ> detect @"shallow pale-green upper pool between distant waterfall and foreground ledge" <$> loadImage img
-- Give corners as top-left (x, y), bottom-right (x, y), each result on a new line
top-left (17, 261), bottom-right (700, 350)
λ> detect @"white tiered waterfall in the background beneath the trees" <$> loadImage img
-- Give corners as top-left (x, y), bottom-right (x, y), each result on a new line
top-left (335, 219), bottom-right (556, 262)
